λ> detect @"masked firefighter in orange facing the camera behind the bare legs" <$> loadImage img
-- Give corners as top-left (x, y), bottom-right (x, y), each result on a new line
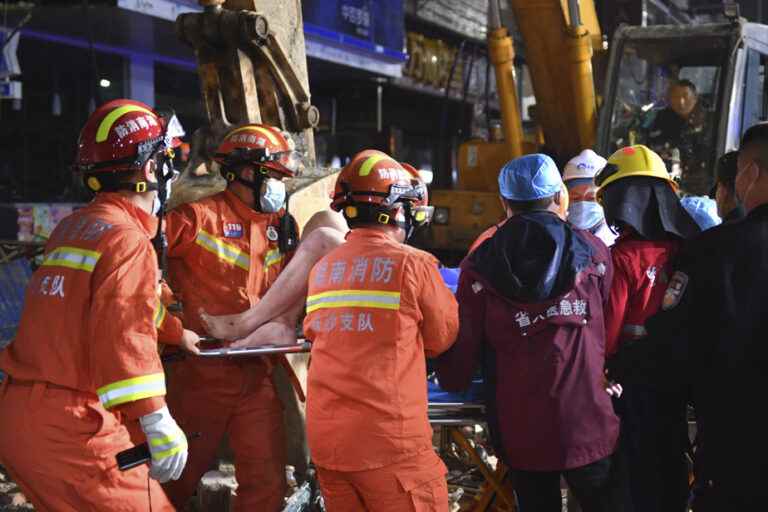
top-left (160, 124), bottom-right (299, 512)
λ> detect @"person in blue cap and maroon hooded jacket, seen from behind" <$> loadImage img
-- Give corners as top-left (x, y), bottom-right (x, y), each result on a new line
top-left (437, 154), bottom-right (624, 512)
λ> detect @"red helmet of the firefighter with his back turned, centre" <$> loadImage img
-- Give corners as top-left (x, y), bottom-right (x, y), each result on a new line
top-left (331, 150), bottom-right (432, 225)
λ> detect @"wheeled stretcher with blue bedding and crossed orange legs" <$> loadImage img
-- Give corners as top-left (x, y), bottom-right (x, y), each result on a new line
top-left (427, 379), bottom-right (517, 512)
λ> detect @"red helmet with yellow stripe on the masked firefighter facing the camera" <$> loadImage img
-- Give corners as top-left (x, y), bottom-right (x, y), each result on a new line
top-left (214, 124), bottom-right (301, 180)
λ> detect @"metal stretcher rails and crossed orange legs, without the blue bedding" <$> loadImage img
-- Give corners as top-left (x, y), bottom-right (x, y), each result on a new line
top-left (428, 402), bottom-right (517, 512)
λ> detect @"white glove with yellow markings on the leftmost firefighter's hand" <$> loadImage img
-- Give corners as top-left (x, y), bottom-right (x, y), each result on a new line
top-left (139, 405), bottom-right (189, 484)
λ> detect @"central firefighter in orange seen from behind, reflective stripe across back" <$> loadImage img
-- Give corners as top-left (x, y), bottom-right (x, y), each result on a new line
top-left (304, 152), bottom-right (458, 512)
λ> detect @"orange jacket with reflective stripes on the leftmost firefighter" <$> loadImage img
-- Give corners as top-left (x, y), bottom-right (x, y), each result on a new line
top-left (0, 193), bottom-right (165, 418)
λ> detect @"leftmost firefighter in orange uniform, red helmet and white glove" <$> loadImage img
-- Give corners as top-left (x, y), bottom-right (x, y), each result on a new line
top-left (0, 100), bottom-right (187, 512)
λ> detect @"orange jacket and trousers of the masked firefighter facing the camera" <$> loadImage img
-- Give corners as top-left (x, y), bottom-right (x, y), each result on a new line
top-left (163, 191), bottom-right (288, 512)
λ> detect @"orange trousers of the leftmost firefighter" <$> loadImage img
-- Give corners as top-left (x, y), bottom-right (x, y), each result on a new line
top-left (0, 379), bottom-right (174, 512)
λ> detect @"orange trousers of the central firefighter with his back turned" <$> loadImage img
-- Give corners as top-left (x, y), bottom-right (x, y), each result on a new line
top-left (317, 450), bottom-right (448, 512)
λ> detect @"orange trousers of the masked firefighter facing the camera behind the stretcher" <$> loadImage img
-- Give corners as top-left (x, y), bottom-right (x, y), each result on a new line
top-left (165, 358), bottom-right (286, 512)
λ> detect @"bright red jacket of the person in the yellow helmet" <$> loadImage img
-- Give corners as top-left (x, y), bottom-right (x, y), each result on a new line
top-left (605, 231), bottom-right (681, 357)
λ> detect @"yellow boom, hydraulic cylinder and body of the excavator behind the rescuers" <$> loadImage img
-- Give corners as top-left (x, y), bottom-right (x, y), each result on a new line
top-left (420, 0), bottom-right (602, 255)
